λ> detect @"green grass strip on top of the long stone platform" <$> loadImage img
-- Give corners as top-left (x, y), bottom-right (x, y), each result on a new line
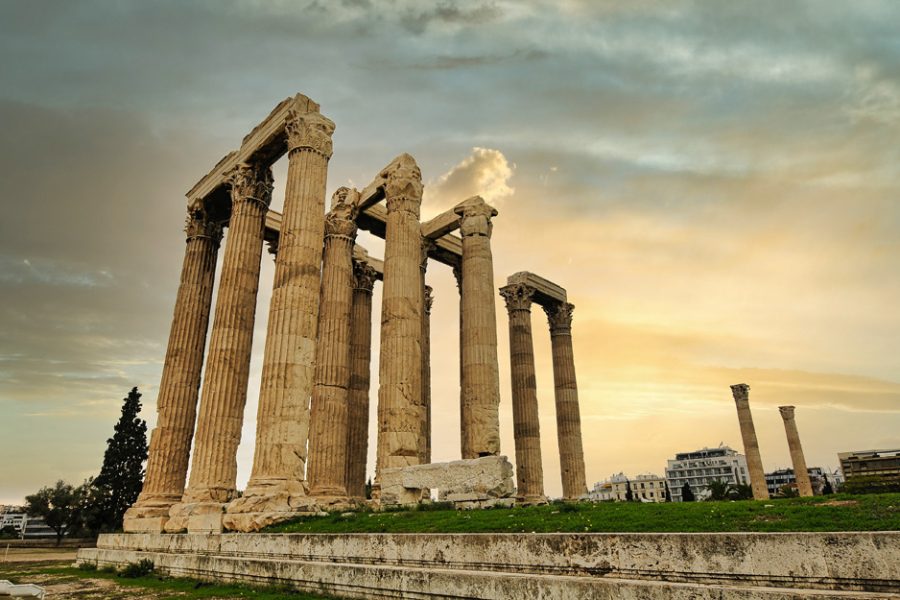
top-left (265, 494), bottom-right (900, 533)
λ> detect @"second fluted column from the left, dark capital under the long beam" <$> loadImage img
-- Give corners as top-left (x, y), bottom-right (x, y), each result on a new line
top-left (166, 164), bottom-right (272, 531)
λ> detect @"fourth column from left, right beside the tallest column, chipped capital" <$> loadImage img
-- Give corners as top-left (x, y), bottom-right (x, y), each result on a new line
top-left (307, 187), bottom-right (359, 498)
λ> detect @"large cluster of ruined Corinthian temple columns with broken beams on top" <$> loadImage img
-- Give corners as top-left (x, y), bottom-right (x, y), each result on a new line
top-left (124, 94), bottom-right (586, 532)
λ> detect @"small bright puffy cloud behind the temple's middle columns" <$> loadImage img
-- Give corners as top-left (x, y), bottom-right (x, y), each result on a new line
top-left (425, 147), bottom-right (516, 212)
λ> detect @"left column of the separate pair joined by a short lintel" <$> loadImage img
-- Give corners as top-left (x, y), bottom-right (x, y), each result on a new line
top-left (500, 284), bottom-right (546, 504)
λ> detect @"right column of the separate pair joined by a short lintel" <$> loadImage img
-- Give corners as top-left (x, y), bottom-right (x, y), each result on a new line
top-left (544, 302), bottom-right (587, 499)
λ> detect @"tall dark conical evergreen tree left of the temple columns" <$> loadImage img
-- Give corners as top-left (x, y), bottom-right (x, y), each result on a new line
top-left (86, 388), bottom-right (147, 532)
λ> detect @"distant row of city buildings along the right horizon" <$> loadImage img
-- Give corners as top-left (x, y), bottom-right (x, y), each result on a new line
top-left (588, 444), bottom-right (900, 502)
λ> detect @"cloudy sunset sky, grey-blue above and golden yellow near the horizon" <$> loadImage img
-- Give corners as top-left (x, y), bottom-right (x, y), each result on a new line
top-left (0, 0), bottom-right (900, 503)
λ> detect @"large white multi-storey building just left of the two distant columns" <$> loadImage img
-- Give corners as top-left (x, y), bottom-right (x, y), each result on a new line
top-left (666, 446), bottom-right (750, 502)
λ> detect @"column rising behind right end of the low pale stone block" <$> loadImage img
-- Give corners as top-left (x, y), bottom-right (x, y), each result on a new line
top-left (454, 196), bottom-right (500, 459)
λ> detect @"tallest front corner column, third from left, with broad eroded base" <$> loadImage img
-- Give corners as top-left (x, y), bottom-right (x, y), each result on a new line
top-left (226, 111), bottom-right (334, 530)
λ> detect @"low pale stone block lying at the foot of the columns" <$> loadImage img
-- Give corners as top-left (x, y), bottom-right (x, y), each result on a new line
top-left (381, 456), bottom-right (516, 508)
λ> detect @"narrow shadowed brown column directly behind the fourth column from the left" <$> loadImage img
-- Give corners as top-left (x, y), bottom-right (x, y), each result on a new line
top-left (347, 262), bottom-right (377, 500)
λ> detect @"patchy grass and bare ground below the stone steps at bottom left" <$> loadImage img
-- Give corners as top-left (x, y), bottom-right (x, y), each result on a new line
top-left (0, 562), bottom-right (331, 600)
